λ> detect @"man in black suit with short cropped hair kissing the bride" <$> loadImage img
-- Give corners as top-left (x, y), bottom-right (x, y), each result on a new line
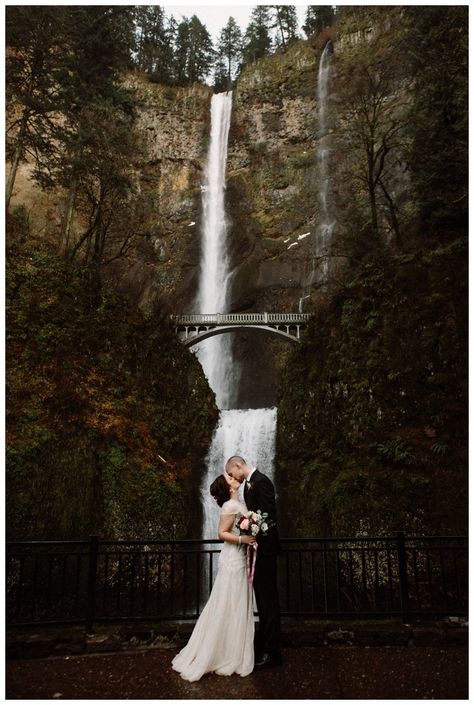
top-left (225, 455), bottom-right (281, 668)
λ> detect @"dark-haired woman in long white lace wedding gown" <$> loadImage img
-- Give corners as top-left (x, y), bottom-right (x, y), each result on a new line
top-left (172, 475), bottom-right (255, 681)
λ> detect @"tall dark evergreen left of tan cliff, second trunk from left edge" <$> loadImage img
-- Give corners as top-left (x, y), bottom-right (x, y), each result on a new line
top-left (41, 6), bottom-right (134, 250)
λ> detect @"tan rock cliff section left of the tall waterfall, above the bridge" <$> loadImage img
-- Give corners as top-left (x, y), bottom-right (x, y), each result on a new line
top-left (107, 75), bottom-right (212, 313)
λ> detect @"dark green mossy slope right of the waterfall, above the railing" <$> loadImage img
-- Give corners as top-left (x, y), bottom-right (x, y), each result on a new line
top-left (277, 239), bottom-right (467, 536)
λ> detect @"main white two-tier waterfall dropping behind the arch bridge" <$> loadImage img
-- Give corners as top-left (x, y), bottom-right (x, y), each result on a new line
top-left (196, 92), bottom-right (276, 544)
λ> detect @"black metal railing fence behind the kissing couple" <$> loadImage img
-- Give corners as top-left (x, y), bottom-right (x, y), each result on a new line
top-left (6, 532), bottom-right (468, 629)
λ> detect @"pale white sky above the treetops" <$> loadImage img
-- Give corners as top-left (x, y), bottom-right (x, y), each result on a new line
top-left (165, 3), bottom-right (308, 40)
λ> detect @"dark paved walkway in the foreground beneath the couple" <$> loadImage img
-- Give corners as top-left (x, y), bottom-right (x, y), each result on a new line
top-left (6, 645), bottom-right (468, 700)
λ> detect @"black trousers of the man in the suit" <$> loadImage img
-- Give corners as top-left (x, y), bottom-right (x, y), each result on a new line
top-left (253, 553), bottom-right (280, 653)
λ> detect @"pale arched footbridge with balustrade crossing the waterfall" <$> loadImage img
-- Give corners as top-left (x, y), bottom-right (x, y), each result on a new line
top-left (171, 313), bottom-right (311, 348)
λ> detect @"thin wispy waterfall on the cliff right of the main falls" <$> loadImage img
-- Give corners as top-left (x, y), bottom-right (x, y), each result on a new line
top-left (300, 41), bottom-right (336, 310)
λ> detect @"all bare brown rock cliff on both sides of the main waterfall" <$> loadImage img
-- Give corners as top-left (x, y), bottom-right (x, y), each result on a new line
top-left (12, 42), bottom-right (330, 406)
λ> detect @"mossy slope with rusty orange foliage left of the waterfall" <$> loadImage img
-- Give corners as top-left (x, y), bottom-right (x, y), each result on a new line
top-left (7, 220), bottom-right (217, 539)
